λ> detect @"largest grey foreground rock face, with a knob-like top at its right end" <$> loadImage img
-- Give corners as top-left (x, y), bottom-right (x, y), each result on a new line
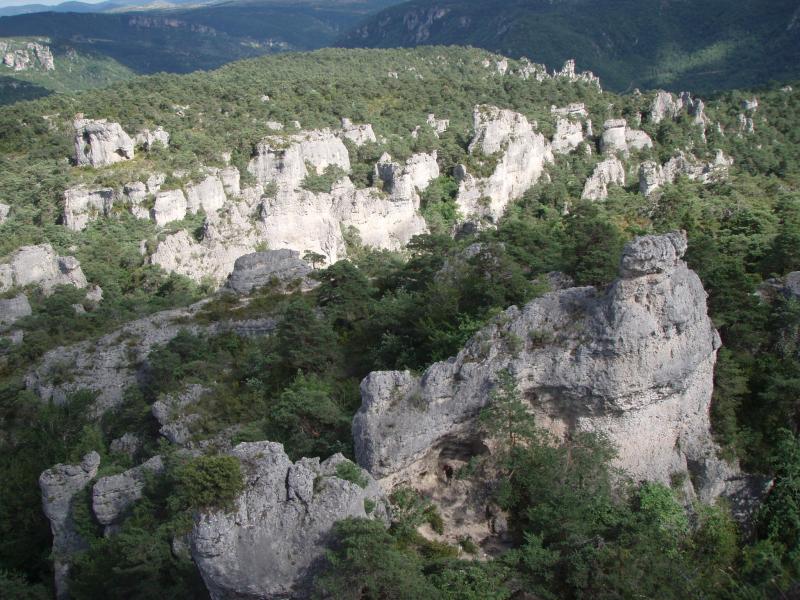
top-left (353, 233), bottom-right (739, 501)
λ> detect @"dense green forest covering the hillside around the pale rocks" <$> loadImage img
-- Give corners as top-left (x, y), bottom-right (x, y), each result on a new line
top-left (0, 47), bottom-right (800, 600)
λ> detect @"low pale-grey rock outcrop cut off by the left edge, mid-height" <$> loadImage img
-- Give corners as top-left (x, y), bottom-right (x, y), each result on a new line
top-left (0, 244), bottom-right (87, 294)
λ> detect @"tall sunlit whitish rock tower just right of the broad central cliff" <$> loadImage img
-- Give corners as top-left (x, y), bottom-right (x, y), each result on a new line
top-left (456, 105), bottom-right (553, 222)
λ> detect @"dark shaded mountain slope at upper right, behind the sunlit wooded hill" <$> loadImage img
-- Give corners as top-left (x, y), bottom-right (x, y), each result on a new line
top-left (338, 0), bottom-right (800, 91)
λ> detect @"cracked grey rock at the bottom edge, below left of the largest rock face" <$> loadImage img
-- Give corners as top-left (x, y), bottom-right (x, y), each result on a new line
top-left (191, 442), bottom-right (385, 600)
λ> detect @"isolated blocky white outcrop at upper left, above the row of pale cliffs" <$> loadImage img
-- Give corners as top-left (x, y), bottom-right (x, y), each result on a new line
top-left (74, 116), bottom-right (134, 167)
